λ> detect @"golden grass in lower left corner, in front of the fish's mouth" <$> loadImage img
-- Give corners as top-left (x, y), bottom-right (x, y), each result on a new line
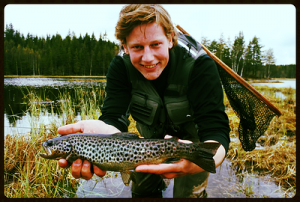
top-left (4, 99), bottom-right (77, 198)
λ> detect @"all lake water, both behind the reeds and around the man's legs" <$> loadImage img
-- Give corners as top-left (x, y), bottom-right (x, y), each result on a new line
top-left (4, 78), bottom-right (296, 198)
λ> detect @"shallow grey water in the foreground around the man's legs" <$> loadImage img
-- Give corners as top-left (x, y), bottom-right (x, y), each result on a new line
top-left (76, 159), bottom-right (285, 198)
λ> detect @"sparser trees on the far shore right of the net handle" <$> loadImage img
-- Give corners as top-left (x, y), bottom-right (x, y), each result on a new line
top-left (201, 32), bottom-right (296, 78)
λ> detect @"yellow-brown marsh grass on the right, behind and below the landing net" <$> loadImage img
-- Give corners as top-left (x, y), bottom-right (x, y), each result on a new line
top-left (225, 86), bottom-right (296, 194)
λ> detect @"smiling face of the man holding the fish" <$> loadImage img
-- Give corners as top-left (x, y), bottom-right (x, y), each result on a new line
top-left (123, 22), bottom-right (173, 80)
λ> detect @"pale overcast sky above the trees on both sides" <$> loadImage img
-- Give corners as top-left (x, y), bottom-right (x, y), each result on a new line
top-left (4, 4), bottom-right (296, 65)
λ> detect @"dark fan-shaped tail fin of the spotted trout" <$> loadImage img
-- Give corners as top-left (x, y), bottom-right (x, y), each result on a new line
top-left (186, 143), bottom-right (220, 173)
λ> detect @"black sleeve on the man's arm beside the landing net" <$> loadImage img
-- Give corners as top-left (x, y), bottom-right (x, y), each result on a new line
top-left (188, 55), bottom-right (230, 152)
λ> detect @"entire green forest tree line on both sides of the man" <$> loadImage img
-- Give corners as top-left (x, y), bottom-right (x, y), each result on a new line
top-left (4, 24), bottom-right (296, 78)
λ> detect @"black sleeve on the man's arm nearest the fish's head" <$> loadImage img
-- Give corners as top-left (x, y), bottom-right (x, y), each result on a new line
top-left (99, 56), bottom-right (131, 132)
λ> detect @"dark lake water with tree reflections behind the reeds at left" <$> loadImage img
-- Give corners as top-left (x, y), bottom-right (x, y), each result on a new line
top-left (4, 78), bottom-right (105, 135)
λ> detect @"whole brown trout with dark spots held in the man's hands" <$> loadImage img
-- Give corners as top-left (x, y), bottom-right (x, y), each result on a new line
top-left (40, 133), bottom-right (220, 185)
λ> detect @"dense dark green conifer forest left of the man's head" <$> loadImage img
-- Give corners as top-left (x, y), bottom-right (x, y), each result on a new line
top-left (4, 24), bottom-right (119, 76)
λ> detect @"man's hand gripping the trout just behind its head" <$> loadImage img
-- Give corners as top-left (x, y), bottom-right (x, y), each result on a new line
top-left (57, 120), bottom-right (120, 180)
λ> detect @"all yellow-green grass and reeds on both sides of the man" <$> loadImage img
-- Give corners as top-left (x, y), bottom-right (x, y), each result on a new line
top-left (4, 81), bottom-right (296, 198)
